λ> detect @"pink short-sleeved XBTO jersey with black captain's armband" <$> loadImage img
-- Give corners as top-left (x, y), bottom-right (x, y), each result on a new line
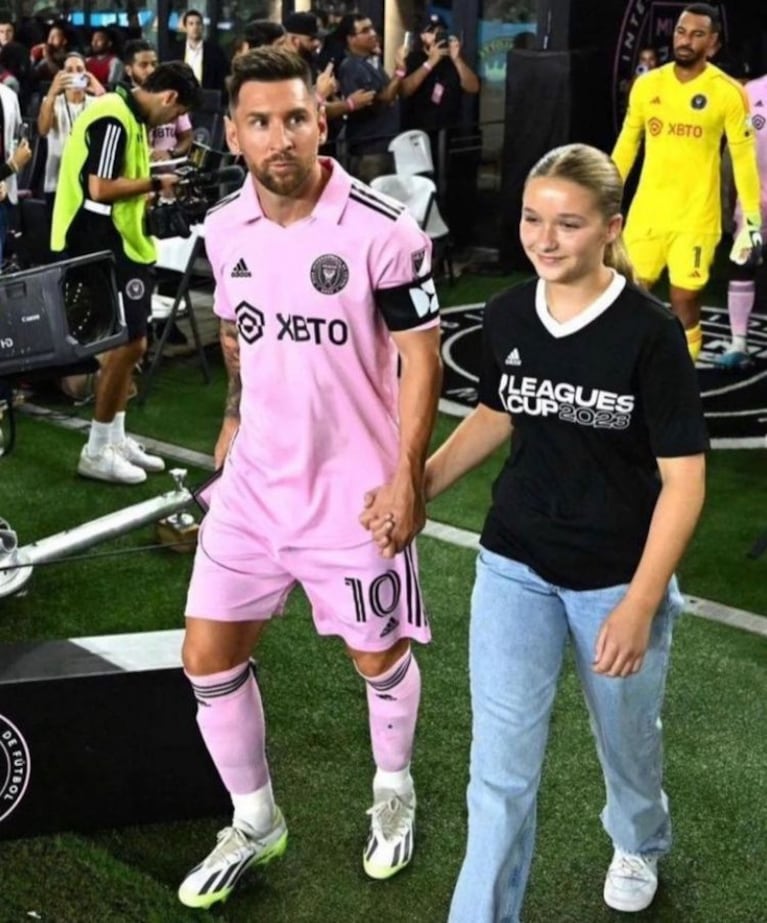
top-left (204, 160), bottom-right (439, 558)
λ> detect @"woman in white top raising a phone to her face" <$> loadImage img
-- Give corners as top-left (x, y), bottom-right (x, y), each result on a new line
top-left (37, 51), bottom-right (106, 215)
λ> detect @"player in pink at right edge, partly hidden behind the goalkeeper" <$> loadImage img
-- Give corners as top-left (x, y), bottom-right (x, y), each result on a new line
top-left (717, 67), bottom-right (767, 369)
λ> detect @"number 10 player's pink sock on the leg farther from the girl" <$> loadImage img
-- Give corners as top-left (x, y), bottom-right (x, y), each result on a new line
top-left (186, 663), bottom-right (269, 795)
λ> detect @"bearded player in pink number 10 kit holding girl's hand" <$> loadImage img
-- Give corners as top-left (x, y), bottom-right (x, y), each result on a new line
top-left (179, 48), bottom-right (441, 907)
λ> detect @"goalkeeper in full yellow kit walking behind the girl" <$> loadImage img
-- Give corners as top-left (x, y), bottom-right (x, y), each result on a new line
top-left (612, 3), bottom-right (762, 359)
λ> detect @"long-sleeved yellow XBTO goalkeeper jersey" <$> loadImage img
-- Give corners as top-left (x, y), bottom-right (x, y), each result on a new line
top-left (612, 63), bottom-right (760, 234)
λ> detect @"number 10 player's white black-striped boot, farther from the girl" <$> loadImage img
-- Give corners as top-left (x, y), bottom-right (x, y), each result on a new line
top-left (178, 808), bottom-right (288, 910)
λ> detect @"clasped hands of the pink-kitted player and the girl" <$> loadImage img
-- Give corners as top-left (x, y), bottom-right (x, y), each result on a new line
top-left (360, 475), bottom-right (426, 558)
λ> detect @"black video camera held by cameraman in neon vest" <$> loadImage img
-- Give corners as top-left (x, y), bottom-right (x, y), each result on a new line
top-left (146, 163), bottom-right (245, 239)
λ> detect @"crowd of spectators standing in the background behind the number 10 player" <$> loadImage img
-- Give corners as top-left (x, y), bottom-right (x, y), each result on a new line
top-left (0, 9), bottom-right (479, 274)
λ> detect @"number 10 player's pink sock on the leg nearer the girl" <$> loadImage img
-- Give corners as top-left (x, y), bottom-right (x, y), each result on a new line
top-left (365, 651), bottom-right (421, 772)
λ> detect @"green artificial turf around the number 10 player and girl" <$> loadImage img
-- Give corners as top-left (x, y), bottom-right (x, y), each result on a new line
top-left (0, 262), bottom-right (767, 923)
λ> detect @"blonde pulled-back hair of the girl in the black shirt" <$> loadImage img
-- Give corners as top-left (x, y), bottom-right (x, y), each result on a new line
top-left (525, 144), bottom-right (636, 282)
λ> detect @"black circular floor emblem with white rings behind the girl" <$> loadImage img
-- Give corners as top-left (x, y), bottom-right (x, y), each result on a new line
top-left (440, 304), bottom-right (767, 448)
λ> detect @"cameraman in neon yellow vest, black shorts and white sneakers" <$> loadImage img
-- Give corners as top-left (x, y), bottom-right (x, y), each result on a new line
top-left (51, 61), bottom-right (202, 484)
